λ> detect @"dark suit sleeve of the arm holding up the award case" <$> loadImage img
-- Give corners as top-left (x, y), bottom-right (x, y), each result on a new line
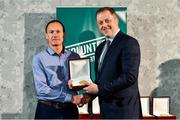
top-left (98, 38), bottom-right (140, 98)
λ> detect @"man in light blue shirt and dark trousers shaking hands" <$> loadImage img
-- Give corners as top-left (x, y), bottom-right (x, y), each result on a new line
top-left (32, 20), bottom-right (83, 119)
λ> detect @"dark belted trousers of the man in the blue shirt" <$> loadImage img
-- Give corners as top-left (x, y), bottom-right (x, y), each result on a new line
top-left (35, 101), bottom-right (79, 119)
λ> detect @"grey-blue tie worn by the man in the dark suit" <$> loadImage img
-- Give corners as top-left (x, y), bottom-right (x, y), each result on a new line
top-left (98, 40), bottom-right (111, 71)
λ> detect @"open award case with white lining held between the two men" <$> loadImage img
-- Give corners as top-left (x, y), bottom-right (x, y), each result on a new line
top-left (69, 58), bottom-right (92, 90)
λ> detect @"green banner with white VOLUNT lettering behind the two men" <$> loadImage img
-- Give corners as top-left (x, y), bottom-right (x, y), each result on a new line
top-left (56, 7), bottom-right (127, 81)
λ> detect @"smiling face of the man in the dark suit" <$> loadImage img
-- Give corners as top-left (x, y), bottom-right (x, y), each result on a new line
top-left (96, 10), bottom-right (118, 38)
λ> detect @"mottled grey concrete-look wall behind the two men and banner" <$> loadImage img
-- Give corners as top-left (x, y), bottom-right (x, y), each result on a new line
top-left (0, 0), bottom-right (180, 119)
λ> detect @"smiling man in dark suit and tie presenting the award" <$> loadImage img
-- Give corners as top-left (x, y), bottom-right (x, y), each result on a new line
top-left (84, 7), bottom-right (142, 119)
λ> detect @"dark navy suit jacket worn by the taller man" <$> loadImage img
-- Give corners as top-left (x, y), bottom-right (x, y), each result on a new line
top-left (95, 32), bottom-right (142, 119)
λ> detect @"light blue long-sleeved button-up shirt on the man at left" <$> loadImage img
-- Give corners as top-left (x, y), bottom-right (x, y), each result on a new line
top-left (32, 47), bottom-right (79, 103)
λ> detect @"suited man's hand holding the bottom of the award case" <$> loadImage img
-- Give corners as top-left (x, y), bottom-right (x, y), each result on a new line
top-left (83, 82), bottom-right (99, 94)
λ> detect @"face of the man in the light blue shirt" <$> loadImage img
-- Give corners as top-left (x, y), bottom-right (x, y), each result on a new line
top-left (46, 22), bottom-right (64, 47)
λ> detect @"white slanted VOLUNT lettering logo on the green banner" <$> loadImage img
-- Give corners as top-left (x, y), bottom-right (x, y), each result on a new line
top-left (66, 36), bottom-right (105, 62)
